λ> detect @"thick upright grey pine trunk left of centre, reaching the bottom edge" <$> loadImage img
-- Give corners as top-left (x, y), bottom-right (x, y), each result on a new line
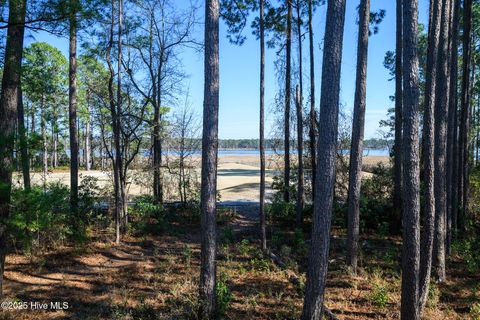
top-left (199, 0), bottom-right (220, 319)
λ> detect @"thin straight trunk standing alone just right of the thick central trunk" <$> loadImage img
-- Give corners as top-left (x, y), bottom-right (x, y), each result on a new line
top-left (260, 0), bottom-right (267, 250)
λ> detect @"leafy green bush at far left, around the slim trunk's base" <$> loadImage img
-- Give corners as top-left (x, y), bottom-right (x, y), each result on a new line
top-left (7, 176), bottom-right (100, 252)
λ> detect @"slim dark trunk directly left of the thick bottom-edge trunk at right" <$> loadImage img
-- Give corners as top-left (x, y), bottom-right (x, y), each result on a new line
top-left (393, 0), bottom-right (403, 226)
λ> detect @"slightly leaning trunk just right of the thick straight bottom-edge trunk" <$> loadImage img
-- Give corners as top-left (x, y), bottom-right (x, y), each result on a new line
top-left (419, 0), bottom-right (442, 312)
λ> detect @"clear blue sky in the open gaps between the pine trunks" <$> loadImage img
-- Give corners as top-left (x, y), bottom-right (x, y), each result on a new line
top-left (26, 0), bottom-right (428, 139)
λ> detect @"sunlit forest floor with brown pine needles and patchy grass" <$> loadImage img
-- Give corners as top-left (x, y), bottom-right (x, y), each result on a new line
top-left (0, 204), bottom-right (480, 320)
